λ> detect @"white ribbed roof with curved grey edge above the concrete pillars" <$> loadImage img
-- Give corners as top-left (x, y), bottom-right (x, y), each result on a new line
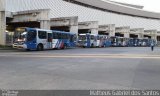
top-left (5, 0), bottom-right (160, 30)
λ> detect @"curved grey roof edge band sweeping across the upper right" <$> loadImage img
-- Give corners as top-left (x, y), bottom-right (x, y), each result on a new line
top-left (65, 0), bottom-right (160, 19)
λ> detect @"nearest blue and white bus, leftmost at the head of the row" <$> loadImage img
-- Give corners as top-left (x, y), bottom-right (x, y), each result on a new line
top-left (13, 27), bottom-right (76, 51)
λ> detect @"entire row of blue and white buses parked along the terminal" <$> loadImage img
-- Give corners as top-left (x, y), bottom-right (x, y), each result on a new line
top-left (13, 27), bottom-right (156, 50)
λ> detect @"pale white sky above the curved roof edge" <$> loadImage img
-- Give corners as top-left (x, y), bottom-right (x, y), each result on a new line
top-left (112, 0), bottom-right (160, 13)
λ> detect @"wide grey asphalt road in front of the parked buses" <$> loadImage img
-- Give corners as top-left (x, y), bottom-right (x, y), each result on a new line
top-left (0, 47), bottom-right (160, 90)
